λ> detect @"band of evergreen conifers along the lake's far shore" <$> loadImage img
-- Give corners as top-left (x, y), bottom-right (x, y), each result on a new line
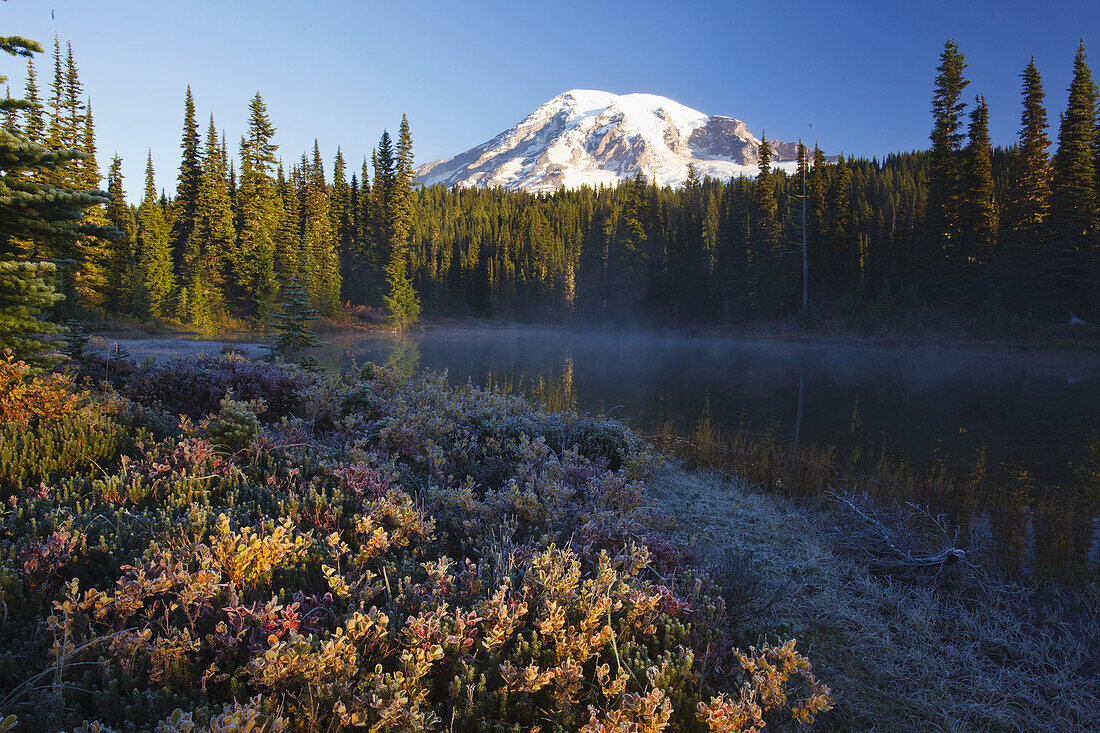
top-left (3, 41), bottom-right (1100, 327)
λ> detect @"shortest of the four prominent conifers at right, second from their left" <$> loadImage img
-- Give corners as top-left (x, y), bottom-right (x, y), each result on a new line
top-left (959, 96), bottom-right (997, 264)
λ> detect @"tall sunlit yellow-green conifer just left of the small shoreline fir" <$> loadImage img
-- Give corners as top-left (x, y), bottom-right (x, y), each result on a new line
top-left (233, 92), bottom-right (278, 322)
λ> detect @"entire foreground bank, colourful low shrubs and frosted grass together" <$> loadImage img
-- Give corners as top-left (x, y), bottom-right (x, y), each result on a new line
top-left (0, 343), bottom-right (1100, 731)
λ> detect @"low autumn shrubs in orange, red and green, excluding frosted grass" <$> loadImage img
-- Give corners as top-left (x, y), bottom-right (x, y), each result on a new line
top-left (0, 355), bottom-right (833, 733)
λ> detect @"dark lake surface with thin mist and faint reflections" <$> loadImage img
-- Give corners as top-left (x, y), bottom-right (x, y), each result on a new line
top-left (310, 328), bottom-right (1100, 573)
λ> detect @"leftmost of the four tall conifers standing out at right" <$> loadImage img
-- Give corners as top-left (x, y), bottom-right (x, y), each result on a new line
top-left (928, 39), bottom-right (969, 263)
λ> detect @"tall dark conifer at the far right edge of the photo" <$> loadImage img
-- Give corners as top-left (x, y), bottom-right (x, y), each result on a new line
top-left (1045, 42), bottom-right (1100, 319)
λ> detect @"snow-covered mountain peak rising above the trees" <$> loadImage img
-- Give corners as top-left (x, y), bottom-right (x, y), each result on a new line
top-left (417, 89), bottom-right (798, 192)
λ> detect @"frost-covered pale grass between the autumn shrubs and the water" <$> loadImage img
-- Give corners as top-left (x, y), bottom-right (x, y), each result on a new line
top-left (650, 466), bottom-right (1100, 731)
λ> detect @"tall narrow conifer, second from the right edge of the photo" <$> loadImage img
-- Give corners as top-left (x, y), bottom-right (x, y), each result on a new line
top-left (1007, 56), bottom-right (1051, 250)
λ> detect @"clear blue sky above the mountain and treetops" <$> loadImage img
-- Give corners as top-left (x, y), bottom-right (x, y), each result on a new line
top-left (0, 0), bottom-right (1100, 199)
